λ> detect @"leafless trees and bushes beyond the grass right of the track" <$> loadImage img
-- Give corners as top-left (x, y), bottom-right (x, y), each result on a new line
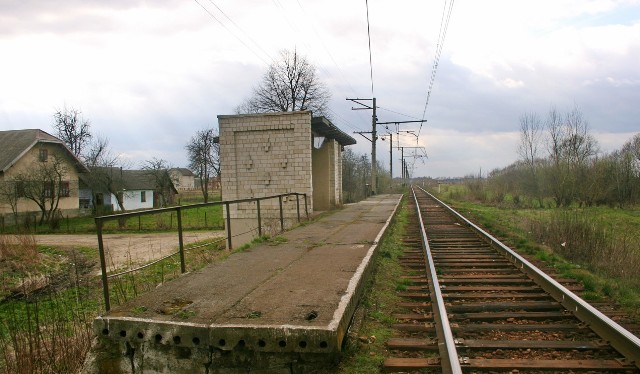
top-left (470, 108), bottom-right (640, 207)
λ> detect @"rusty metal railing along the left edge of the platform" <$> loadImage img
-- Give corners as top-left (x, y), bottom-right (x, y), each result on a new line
top-left (95, 192), bottom-right (309, 312)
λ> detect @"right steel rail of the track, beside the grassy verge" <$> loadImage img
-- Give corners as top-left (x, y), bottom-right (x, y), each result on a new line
top-left (414, 186), bottom-right (640, 368)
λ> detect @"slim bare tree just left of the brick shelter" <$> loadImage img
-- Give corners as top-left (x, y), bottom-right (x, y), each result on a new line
top-left (185, 129), bottom-right (220, 203)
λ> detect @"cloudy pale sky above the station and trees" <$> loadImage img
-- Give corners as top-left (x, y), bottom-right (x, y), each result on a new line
top-left (0, 0), bottom-right (640, 177)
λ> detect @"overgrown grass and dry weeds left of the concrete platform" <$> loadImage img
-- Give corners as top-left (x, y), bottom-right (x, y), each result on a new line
top-left (0, 231), bottom-right (230, 373)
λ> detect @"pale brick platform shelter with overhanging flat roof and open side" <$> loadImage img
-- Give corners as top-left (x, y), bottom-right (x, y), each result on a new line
top-left (218, 111), bottom-right (355, 247)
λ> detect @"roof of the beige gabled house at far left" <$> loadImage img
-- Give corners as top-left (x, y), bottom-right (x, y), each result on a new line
top-left (0, 129), bottom-right (87, 173)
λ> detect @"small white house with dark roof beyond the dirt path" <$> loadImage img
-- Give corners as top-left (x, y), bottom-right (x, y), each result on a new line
top-left (80, 167), bottom-right (178, 213)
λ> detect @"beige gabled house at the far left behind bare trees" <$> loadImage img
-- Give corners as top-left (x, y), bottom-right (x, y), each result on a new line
top-left (0, 129), bottom-right (88, 219)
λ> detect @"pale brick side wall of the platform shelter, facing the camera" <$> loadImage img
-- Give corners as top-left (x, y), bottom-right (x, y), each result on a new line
top-left (218, 112), bottom-right (313, 246)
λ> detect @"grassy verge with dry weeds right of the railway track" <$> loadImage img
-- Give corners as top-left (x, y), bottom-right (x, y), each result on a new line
top-left (439, 186), bottom-right (640, 321)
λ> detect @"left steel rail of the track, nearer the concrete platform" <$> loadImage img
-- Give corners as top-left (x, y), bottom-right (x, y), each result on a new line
top-left (411, 187), bottom-right (462, 374)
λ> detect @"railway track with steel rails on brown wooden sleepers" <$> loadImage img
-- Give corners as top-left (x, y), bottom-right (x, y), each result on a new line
top-left (383, 189), bottom-right (640, 373)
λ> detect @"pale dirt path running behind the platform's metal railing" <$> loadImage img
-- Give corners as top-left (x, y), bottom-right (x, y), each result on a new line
top-left (35, 231), bottom-right (225, 269)
